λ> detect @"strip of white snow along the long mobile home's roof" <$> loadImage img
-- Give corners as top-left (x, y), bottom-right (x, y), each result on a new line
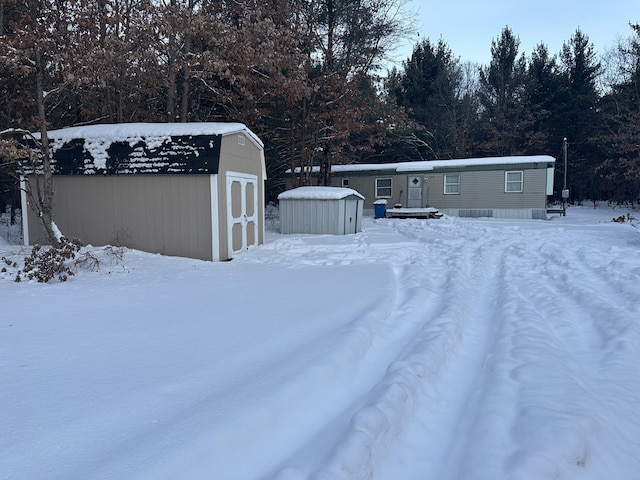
top-left (287, 155), bottom-right (556, 173)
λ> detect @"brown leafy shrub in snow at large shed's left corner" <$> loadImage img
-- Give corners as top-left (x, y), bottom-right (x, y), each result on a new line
top-left (16, 237), bottom-right (82, 283)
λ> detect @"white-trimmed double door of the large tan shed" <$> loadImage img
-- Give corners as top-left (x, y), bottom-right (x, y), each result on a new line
top-left (227, 172), bottom-right (258, 258)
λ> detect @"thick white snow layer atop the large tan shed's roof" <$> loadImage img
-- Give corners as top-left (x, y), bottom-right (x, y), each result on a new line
top-left (34, 122), bottom-right (264, 147)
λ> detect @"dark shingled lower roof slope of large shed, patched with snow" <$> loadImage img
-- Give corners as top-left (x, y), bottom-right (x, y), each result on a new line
top-left (52, 135), bottom-right (222, 175)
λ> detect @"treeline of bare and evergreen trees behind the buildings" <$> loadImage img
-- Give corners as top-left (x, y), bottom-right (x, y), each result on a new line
top-left (0, 0), bottom-right (640, 203)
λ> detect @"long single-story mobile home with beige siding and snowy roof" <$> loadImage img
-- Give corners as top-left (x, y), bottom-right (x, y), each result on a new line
top-left (288, 155), bottom-right (555, 219)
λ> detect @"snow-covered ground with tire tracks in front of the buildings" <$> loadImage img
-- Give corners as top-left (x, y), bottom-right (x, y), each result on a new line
top-left (0, 207), bottom-right (640, 480)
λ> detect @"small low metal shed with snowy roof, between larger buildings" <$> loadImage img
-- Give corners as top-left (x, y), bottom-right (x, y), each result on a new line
top-left (278, 187), bottom-right (364, 235)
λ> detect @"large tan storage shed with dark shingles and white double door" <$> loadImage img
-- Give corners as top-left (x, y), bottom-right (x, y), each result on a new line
top-left (22, 123), bottom-right (266, 261)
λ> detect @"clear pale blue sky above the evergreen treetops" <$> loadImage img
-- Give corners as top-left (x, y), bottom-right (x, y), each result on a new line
top-left (397, 0), bottom-right (640, 64)
